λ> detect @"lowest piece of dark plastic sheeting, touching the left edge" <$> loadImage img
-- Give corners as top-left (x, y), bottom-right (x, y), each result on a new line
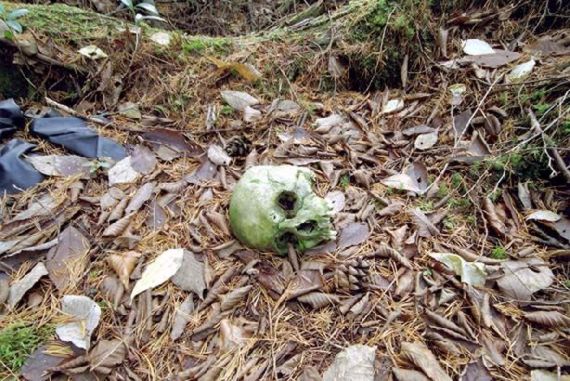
top-left (0, 139), bottom-right (44, 195)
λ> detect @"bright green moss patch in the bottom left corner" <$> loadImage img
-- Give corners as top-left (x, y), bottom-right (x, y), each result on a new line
top-left (0, 324), bottom-right (54, 373)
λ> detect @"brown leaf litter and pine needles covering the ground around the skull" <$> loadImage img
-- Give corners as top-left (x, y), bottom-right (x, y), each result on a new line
top-left (0, 2), bottom-right (570, 380)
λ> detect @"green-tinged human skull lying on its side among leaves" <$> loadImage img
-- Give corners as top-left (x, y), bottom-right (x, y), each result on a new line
top-left (230, 165), bottom-right (336, 254)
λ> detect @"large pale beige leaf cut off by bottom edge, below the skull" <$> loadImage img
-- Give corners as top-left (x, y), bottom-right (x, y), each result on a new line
top-left (323, 344), bottom-right (376, 381)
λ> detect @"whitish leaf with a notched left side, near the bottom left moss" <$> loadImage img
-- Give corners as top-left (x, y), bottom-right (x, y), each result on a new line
top-left (55, 295), bottom-right (101, 350)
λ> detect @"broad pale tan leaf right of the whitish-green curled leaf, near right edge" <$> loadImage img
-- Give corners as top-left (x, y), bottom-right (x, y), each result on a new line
top-left (497, 258), bottom-right (554, 300)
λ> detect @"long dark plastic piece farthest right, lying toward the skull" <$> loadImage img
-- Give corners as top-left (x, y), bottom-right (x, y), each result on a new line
top-left (31, 117), bottom-right (127, 160)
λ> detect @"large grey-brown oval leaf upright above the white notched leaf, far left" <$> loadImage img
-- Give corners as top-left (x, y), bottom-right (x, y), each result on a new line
top-left (45, 225), bottom-right (90, 291)
